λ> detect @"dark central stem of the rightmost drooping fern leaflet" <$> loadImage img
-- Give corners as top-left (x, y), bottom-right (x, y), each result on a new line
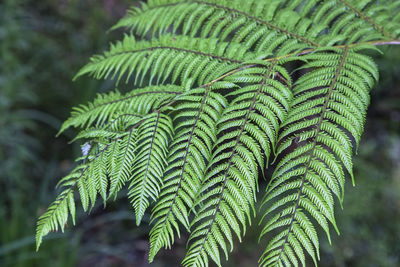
top-left (277, 46), bottom-right (349, 262)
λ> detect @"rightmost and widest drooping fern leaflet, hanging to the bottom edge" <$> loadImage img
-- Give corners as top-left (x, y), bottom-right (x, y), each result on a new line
top-left (260, 47), bottom-right (377, 266)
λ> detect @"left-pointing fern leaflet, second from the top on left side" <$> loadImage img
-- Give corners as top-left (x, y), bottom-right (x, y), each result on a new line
top-left (75, 35), bottom-right (255, 85)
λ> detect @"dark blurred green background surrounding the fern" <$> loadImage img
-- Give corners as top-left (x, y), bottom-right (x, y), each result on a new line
top-left (0, 0), bottom-right (400, 267)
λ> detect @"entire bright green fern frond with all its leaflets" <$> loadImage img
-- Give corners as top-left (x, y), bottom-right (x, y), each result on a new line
top-left (36, 0), bottom-right (400, 266)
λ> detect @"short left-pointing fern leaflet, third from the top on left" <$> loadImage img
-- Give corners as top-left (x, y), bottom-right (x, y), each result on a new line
top-left (58, 85), bottom-right (183, 135)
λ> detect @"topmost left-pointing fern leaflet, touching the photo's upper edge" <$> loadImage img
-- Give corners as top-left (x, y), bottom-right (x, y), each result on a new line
top-left (113, 0), bottom-right (325, 55)
